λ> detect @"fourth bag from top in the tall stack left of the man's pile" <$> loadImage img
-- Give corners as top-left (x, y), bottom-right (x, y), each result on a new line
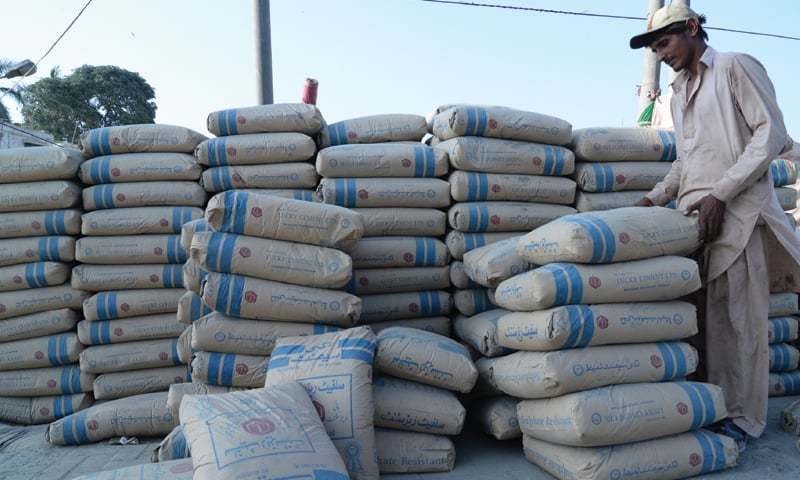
top-left (447, 202), bottom-right (576, 232)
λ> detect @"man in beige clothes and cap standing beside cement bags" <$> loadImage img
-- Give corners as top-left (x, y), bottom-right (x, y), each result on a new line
top-left (630, 3), bottom-right (800, 447)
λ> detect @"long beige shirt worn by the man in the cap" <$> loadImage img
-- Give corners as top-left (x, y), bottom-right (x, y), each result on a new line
top-left (647, 47), bottom-right (800, 280)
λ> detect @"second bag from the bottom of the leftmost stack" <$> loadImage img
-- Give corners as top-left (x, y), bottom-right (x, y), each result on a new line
top-left (0, 366), bottom-right (94, 397)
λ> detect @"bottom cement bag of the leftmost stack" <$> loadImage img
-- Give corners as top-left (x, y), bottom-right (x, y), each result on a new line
top-left (0, 393), bottom-right (92, 425)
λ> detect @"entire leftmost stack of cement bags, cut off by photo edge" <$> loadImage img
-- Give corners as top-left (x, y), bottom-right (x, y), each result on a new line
top-left (0, 147), bottom-right (94, 425)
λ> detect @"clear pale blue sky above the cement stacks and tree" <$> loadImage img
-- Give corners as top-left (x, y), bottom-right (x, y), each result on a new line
top-left (0, 0), bottom-right (800, 139)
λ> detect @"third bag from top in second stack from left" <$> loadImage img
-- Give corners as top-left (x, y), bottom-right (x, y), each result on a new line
top-left (83, 182), bottom-right (206, 210)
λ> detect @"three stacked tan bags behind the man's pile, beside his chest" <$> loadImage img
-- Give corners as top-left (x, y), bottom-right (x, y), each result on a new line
top-left (572, 128), bottom-right (676, 212)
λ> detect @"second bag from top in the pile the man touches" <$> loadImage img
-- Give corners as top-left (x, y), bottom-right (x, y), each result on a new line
top-left (495, 256), bottom-right (700, 312)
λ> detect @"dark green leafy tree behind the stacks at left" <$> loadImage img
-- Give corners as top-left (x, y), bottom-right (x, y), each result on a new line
top-left (22, 65), bottom-right (157, 141)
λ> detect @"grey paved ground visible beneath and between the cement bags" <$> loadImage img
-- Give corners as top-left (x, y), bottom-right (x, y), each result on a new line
top-left (0, 397), bottom-right (800, 480)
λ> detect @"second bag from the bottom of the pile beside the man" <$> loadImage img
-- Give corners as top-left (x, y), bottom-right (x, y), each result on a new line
top-left (517, 382), bottom-right (728, 447)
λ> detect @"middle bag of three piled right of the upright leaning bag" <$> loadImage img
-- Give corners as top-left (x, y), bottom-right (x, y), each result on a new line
top-left (372, 376), bottom-right (467, 435)
